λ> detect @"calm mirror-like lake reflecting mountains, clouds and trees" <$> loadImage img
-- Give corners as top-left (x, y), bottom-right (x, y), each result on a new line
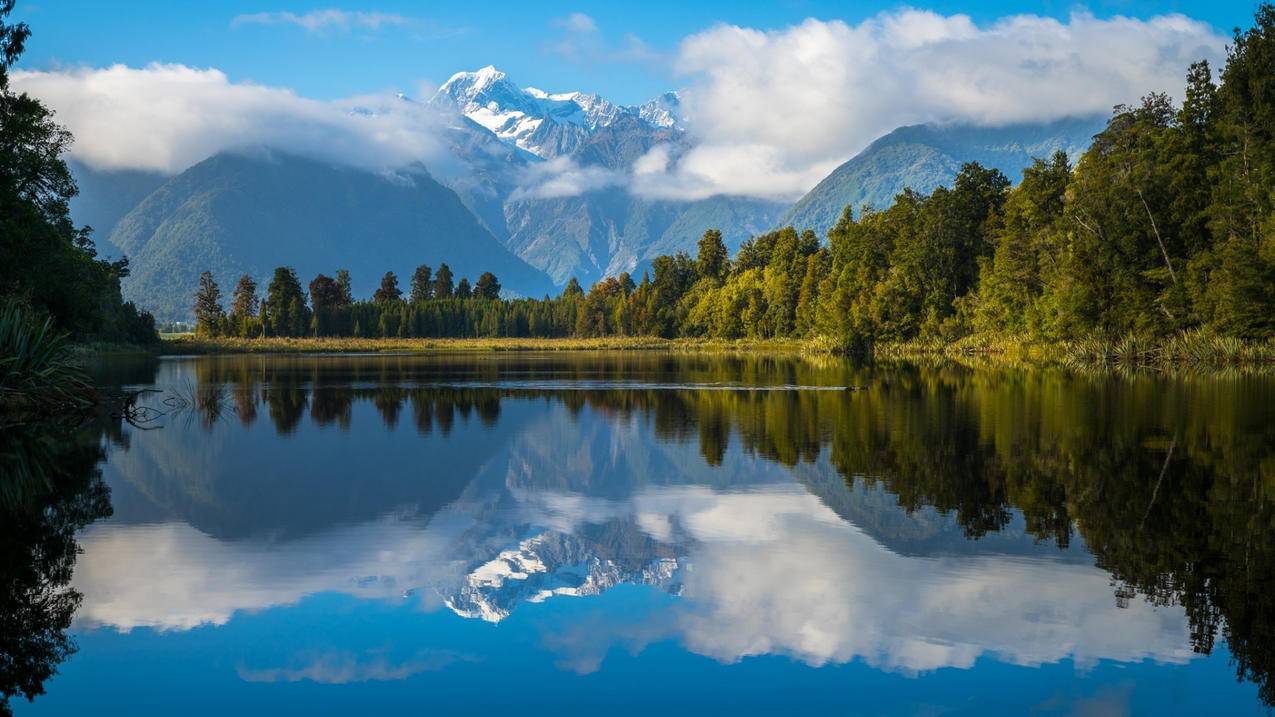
top-left (0, 352), bottom-right (1275, 716)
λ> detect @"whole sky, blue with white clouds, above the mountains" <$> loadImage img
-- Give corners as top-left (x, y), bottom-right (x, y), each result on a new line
top-left (4, 0), bottom-right (1253, 200)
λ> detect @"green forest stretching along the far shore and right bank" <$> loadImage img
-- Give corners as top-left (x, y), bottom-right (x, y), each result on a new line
top-left (188, 3), bottom-right (1275, 350)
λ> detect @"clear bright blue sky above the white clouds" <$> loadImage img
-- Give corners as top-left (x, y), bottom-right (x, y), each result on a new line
top-left (15, 0), bottom-right (1255, 103)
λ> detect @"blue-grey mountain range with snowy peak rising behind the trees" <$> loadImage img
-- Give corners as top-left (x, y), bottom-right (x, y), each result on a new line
top-left (71, 66), bottom-right (1103, 320)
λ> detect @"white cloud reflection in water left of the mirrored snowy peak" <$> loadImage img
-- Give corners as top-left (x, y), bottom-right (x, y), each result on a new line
top-left (75, 519), bottom-right (460, 632)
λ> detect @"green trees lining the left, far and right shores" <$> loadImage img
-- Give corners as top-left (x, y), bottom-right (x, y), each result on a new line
top-left (0, 0), bottom-right (1275, 413)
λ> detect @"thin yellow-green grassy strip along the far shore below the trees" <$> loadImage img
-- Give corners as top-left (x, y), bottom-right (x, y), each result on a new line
top-left (159, 334), bottom-right (811, 356)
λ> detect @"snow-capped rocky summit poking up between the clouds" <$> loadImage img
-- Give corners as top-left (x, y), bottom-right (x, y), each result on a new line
top-left (431, 65), bottom-right (680, 159)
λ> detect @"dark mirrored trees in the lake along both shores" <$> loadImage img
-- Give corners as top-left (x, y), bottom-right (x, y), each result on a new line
top-left (0, 355), bottom-right (1275, 704)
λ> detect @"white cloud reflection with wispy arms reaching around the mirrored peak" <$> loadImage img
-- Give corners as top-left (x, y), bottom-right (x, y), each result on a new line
top-left (507, 477), bottom-right (1193, 674)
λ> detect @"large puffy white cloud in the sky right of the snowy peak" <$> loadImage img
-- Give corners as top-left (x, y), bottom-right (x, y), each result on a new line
top-left (638, 9), bottom-right (1227, 198)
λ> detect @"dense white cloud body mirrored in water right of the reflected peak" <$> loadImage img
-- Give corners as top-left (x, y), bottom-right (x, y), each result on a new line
top-left (680, 505), bottom-right (1192, 674)
